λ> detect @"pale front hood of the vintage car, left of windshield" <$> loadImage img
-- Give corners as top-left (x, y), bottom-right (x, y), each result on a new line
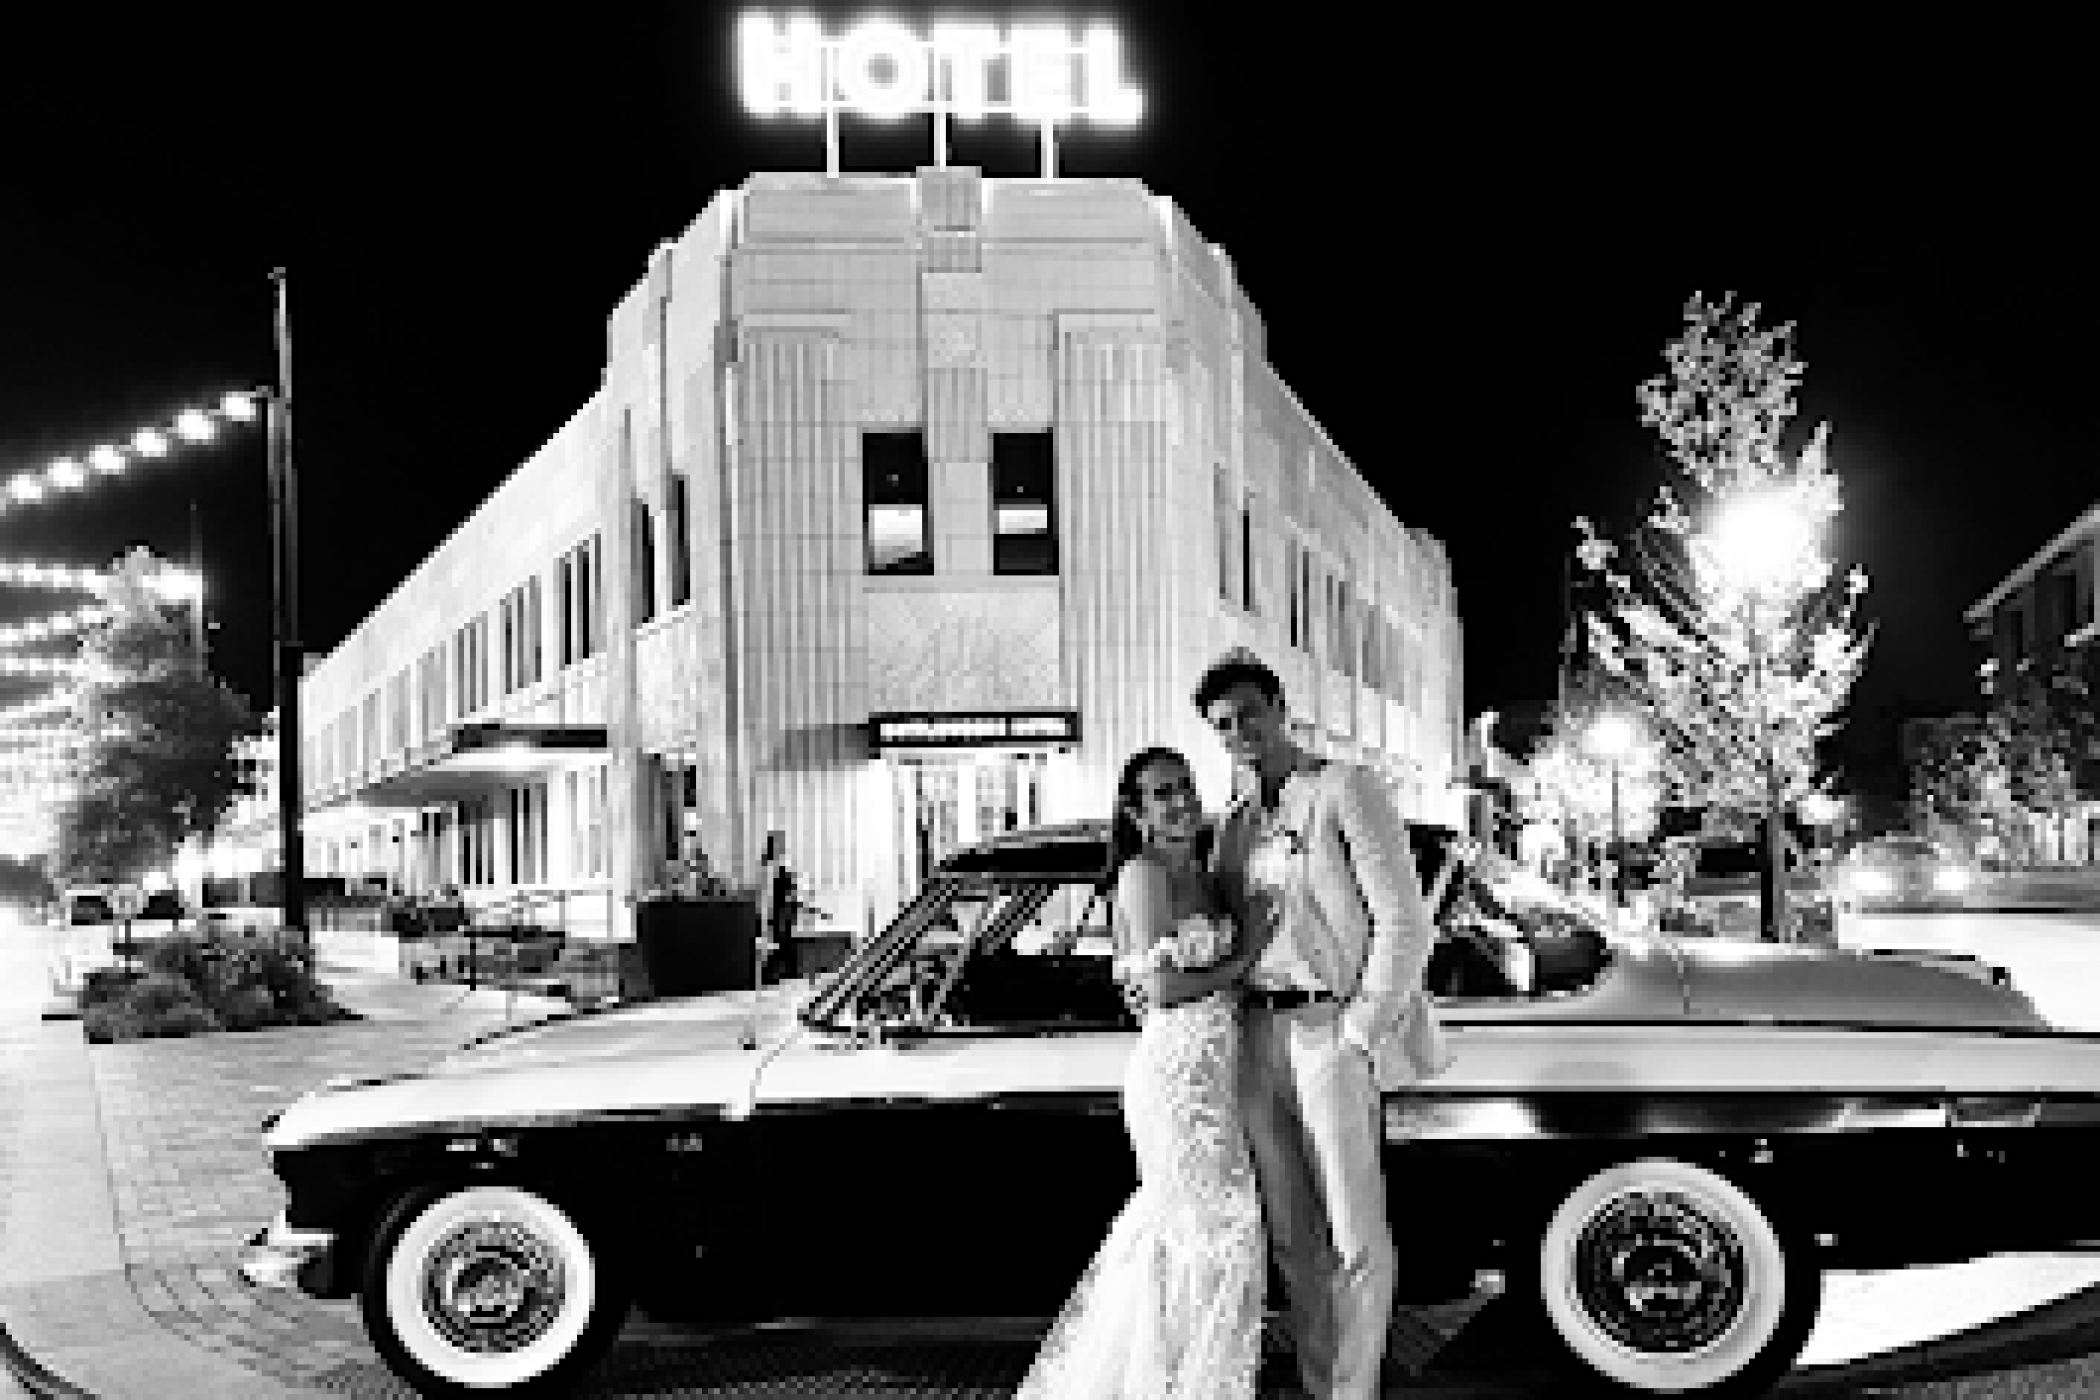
top-left (263, 982), bottom-right (809, 1152)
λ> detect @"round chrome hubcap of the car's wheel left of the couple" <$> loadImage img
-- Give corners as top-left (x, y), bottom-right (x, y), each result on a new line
top-left (422, 1215), bottom-right (567, 1354)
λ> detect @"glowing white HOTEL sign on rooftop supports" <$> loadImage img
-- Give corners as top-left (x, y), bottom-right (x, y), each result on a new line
top-left (737, 13), bottom-right (1145, 176)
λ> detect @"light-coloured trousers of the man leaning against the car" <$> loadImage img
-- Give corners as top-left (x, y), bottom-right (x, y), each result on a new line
top-left (1241, 1001), bottom-right (1399, 1400)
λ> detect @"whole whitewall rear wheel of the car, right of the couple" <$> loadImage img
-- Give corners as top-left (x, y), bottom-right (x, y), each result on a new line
top-left (1512, 1159), bottom-right (1823, 1398)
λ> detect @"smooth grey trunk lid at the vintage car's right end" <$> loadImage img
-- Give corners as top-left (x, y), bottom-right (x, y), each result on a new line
top-left (1676, 938), bottom-right (2050, 1031)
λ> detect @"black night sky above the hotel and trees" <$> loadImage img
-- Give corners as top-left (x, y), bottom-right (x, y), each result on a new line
top-left (0, 4), bottom-right (2100, 787)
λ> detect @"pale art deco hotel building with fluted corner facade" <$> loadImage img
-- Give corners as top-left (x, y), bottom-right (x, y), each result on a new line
top-left (300, 168), bottom-right (1464, 938)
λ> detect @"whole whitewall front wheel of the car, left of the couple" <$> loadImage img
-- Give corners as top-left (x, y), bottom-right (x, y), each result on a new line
top-left (359, 1184), bottom-right (628, 1396)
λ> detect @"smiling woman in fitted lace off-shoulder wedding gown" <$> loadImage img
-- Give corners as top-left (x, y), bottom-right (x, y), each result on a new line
top-left (1019, 749), bottom-right (1268, 1400)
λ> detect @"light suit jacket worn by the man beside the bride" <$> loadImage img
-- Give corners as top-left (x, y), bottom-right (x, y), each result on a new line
top-left (1214, 762), bottom-right (1451, 1089)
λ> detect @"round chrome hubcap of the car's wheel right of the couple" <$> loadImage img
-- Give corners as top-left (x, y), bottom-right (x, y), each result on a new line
top-left (1575, 1192), bottom-right (1745, 1352)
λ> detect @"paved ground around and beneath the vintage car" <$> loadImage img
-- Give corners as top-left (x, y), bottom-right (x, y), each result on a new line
top-left (0, 913), bottom-right (2100, 1400)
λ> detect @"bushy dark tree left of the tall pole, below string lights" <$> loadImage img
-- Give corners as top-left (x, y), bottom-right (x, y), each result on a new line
top-left (55, 604), bottom-right (260, 884)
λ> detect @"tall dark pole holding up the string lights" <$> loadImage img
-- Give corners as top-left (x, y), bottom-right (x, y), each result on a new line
top-left (269, 267), bottom-right (313, 961)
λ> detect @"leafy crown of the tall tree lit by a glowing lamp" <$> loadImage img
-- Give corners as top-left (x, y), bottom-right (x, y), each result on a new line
top-left (1575, 296), bottom-right (1871, 831)
